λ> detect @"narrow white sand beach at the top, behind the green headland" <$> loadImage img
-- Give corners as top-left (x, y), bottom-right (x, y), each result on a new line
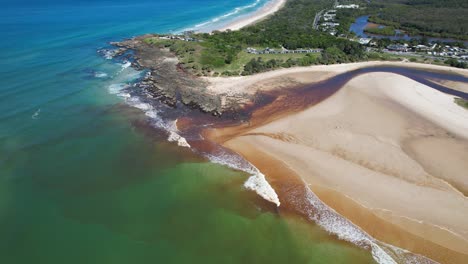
top-left (219, 0), bottom-right (286, 31)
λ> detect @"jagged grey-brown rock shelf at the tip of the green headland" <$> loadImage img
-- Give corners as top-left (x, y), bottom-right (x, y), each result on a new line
top-left (111, 35), bottom-right (254, 116)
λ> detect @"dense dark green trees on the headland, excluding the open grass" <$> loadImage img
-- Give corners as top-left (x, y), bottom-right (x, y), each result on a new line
top-left (190, 0), bottom-right (365, 74)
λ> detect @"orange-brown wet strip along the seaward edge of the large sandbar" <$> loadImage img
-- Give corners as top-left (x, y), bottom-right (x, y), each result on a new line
top-left (226, 138), bottom-right (466, 263)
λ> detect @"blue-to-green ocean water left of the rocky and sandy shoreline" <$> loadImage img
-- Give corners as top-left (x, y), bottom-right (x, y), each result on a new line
top-left (0, 0), bottom-right (372, 264)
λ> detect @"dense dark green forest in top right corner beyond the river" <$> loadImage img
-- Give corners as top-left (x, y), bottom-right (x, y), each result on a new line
top-left (368, 0), bottom-right (468, 40)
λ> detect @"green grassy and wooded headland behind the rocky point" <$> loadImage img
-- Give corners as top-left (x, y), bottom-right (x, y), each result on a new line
top-left (146, 0), bottom-right (366, 76)
